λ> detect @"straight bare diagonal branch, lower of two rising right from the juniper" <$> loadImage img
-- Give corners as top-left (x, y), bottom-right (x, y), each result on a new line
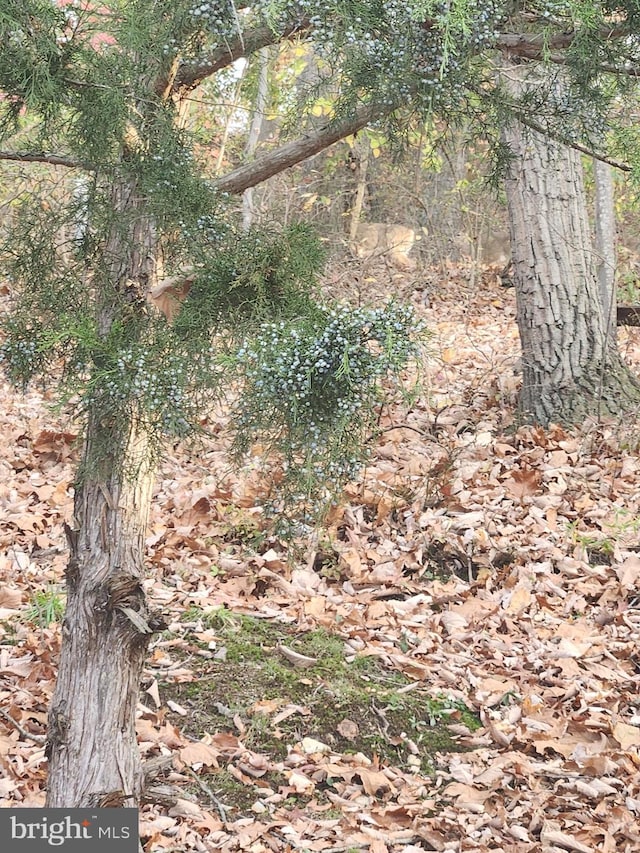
top-left (214, 103), bottom-right (398, 194)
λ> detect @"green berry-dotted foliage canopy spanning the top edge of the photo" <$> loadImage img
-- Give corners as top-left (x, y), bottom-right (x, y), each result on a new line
top-left (0, 0), bottom-right (640, 175)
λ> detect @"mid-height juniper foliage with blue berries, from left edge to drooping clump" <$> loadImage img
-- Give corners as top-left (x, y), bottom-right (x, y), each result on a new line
top-left (0, 197), bottom-right (419, 507)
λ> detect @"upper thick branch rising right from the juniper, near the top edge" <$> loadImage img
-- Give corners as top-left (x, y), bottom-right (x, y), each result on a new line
top-left (172, 18), bottom-right (311, 95)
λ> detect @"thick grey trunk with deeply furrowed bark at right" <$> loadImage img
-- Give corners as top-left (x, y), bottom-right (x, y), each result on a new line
top-left (505, 122), bottom-right (640, 425)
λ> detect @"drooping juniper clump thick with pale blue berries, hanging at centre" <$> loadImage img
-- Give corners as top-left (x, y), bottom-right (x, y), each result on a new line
top-left (234, 302), bottom-right (422, 514)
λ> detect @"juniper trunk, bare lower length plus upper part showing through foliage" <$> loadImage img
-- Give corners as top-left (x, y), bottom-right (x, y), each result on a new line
top-left (46, 180), bottom-right (161, 808)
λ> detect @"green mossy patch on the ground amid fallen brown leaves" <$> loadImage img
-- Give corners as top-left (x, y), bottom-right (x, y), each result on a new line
top-left (163, 609), bottom-right (479, 813)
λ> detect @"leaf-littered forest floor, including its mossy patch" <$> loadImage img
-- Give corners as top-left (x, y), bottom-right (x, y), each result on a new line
top-left (0, 267), bottom-right (640, 853)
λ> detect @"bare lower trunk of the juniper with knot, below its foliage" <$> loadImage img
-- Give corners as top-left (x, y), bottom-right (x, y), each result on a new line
top-left (46, 423), bottom-right (160, 808)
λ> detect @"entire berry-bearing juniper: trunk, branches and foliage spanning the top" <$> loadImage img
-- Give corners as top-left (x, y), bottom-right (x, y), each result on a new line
top-left (0, 0), bottom-right (637, 806)
